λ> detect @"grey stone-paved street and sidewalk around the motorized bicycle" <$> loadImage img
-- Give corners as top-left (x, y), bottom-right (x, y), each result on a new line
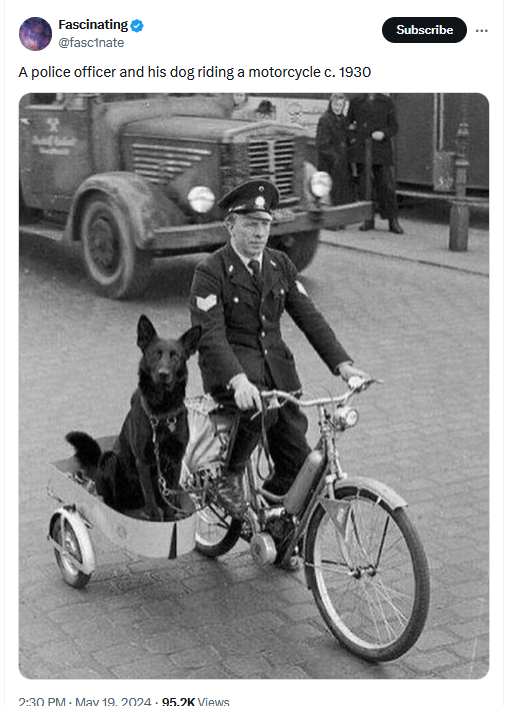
top-left (19, 206), bottom-right (489, 680)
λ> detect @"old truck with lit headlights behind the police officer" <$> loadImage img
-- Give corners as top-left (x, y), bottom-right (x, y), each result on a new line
top-left (19, 93), bottom-right (372, 299)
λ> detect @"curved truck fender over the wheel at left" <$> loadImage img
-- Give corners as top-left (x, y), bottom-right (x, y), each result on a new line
top-left (67, 172), bottom-right (188, 249)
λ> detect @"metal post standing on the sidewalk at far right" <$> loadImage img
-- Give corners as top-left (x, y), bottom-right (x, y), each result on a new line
top-left (449, 93), bottom-right (470, 252)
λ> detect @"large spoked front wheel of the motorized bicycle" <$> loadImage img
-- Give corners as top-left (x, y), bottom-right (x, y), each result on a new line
top-left (305, 487), bottom-right (430, 662)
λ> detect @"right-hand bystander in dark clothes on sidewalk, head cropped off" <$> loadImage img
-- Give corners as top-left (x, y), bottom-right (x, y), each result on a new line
top-left (349, 93), bottom-right (403, 235)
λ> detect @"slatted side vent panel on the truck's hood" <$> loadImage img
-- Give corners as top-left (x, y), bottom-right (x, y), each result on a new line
top-left (132, 142), bottom-right (210, 184)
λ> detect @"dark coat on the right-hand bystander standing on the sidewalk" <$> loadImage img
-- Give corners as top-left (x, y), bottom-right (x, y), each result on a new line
top-left (348, 93), bottom-right (398, 164)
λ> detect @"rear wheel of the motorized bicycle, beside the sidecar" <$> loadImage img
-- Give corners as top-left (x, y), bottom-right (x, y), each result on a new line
top-left (195, 504), bottom-right (242, 559)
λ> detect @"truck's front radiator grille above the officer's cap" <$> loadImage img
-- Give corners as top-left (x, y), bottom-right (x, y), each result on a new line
top-left (247, 137), bottom-right (295, 202)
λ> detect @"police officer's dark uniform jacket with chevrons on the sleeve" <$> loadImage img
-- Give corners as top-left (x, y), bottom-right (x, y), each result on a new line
top-left (190, 244), bottom-right (350, 397)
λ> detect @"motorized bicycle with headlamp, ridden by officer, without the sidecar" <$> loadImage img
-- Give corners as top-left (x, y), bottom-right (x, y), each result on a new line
top-left (186, 378), bottom-right (430, 662)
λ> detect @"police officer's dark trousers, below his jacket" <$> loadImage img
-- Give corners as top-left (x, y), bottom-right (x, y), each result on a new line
top-left (224, 402), bottom-right (311, 495)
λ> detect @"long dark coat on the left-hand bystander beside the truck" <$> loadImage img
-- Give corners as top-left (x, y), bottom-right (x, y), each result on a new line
top-left (316, 101), bottom-right (354, 206)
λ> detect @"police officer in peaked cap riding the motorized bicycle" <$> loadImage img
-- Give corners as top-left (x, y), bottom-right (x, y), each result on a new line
top-left (190, 180), bottom-right (366, 514)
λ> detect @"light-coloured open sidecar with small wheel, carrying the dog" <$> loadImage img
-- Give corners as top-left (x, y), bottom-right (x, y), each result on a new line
top-left (48, 436), bottom-right (197, 588)
